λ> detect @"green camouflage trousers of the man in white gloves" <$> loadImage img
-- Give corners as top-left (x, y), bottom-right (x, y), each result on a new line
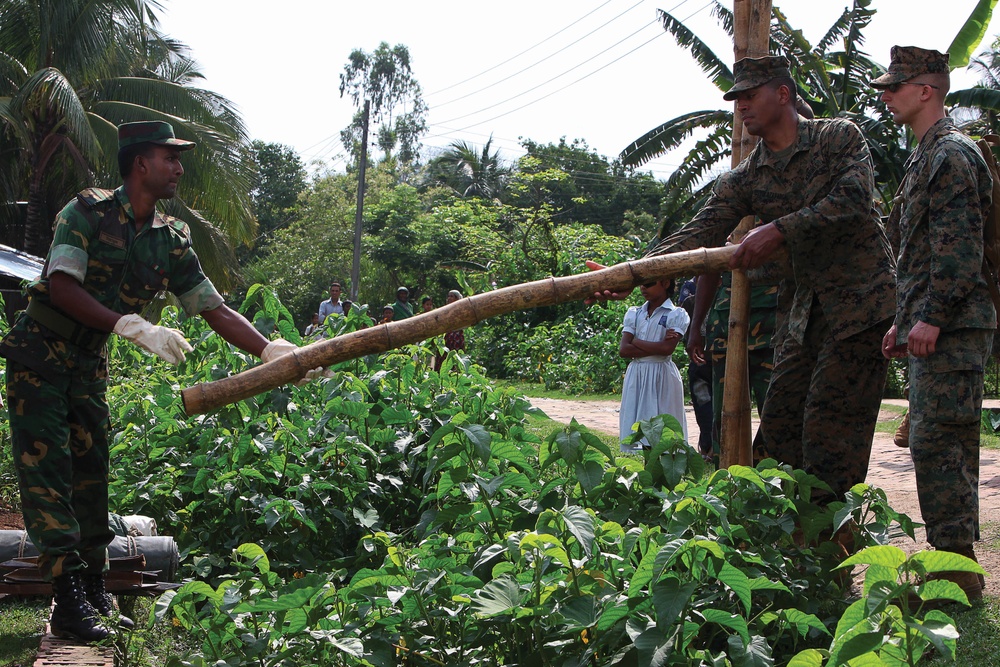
top-left (7, 360), bottom-right (114, 580)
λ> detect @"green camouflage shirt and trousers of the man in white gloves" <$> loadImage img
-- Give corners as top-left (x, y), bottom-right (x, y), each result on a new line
top-left (0, 188), bottom-right (223, 577)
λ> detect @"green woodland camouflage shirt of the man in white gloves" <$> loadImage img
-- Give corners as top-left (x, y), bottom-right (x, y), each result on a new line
top-left (0, 187), bottom-right (223, 373)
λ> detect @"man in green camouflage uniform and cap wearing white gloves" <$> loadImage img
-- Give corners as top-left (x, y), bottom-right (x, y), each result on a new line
top-left (0, 122), bottom-right (316, 642)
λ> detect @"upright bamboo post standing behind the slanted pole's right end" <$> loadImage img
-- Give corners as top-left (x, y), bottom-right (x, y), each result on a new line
top-left (720, 0), bottom-right (771, 467)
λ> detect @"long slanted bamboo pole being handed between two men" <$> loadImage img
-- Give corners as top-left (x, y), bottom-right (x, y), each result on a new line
top-left (181, 246), bottom-right (736, 415)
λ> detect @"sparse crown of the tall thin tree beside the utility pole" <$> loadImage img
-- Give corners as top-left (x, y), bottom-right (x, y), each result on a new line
top-left (340, 42), bottom-right (427, 165)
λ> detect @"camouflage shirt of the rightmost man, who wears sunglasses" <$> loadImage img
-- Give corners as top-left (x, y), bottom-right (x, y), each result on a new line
top-left (887, 118), bottom-right (996, 343)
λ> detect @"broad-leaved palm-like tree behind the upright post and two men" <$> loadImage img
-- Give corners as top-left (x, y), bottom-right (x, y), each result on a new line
top-left (620, 0), bottom-right (996, 236)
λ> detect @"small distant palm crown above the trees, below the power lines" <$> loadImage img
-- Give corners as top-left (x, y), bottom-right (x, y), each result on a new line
top-left (428, 136), bottom-right (510, 199)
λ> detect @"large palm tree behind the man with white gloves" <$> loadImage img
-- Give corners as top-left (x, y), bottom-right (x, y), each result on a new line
top-left (0, 0), bottom-right (256, 289)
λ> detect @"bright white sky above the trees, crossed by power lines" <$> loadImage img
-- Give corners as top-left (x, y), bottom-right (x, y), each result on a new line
top-left (159, 0), bottom-right (1000, 178)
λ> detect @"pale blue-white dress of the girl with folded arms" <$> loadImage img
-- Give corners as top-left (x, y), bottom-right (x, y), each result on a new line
top-left (618, 299), bottom-right (691, 452)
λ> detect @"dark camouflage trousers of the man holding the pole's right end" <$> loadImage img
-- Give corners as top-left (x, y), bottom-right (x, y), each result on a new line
top-left (761, 302), bottom-right (892, 504)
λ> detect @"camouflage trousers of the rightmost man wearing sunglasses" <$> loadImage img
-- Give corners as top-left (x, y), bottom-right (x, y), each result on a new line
top-left (910, 329), bottom-right (993, 551)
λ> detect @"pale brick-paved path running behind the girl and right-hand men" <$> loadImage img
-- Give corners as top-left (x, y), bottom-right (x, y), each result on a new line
top-left (531, 398), bottom-right (1000, 595)
